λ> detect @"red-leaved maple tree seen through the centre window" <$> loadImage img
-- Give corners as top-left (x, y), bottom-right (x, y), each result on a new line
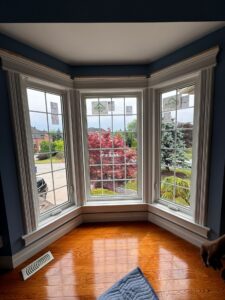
top-left (88, 131), bottom-right (137, 189)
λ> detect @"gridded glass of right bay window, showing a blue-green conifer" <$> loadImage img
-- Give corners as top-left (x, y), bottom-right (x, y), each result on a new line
top-left (160, 85), bottom-right (196, 212)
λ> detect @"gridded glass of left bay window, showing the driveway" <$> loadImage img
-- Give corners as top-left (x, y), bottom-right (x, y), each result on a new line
top-left (26, 87), bottom-right (71, 219)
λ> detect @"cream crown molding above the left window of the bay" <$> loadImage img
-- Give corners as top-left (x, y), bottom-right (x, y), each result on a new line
top-left (0, 49), bottom-right (73, 88)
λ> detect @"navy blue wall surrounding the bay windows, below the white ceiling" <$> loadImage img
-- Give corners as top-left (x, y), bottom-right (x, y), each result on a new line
top-left (0, 25), bottom-right (225, 255)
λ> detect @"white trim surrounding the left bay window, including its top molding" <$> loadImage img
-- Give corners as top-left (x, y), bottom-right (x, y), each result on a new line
top-left (0, 50), bottom-right (76, 235)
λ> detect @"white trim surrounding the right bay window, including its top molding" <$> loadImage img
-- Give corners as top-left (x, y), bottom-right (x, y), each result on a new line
top-left (144, 47), bottom-right (219, 226)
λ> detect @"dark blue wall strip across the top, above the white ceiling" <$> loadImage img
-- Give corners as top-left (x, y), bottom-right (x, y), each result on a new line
top-left (0, 0), bottom-right (225, 22)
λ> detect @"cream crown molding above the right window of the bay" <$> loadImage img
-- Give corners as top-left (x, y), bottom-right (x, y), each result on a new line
top-left (148, 46), bottom-right (219, 88)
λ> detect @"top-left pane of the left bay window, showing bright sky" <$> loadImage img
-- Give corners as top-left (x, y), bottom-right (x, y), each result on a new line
top-left (27, 89), bottom-right (46, 112)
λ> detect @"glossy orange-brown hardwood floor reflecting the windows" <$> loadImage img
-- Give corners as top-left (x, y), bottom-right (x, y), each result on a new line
top-left (0, 222), bottom-right (225, 300)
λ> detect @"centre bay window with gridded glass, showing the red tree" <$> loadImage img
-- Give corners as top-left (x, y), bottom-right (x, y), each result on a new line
top-left (82, 94), bottom-right (142, 200)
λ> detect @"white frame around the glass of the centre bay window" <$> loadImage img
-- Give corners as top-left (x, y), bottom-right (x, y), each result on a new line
top-left (81, 91), bottom-right (143, 204)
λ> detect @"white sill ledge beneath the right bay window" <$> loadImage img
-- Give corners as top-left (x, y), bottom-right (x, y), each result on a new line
top-left (148, 203), bottom-right (210, 238)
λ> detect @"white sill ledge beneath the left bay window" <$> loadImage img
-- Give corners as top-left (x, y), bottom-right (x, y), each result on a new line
top-left (22, 206), bottom-right (81, 246)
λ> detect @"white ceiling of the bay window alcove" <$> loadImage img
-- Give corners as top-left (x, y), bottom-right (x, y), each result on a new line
top-left (0, 22), bottom-right (225, 65)
